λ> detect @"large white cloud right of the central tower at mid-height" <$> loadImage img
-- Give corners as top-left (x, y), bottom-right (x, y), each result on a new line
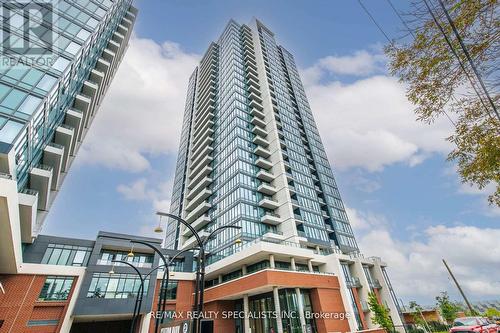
top-left (305, 66), bottom-right (451, 172)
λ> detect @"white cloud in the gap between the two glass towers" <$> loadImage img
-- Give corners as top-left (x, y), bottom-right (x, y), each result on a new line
top-left (79, 36), bottom-right (199, 172)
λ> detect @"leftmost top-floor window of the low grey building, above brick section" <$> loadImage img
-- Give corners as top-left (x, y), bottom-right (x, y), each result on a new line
top-left (42, 244), bottom-right (92, 266)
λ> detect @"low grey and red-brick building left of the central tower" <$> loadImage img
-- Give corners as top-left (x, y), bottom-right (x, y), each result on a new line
top-left (0, 232), bottom-right (194, 333)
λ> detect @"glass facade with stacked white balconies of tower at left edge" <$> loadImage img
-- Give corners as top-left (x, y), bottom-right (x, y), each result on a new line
top-left (0, 0), bottom-right (137, 273)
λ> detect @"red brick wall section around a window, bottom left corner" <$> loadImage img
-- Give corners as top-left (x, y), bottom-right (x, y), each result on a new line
top-left (0, 274), bottom-right (77, 333)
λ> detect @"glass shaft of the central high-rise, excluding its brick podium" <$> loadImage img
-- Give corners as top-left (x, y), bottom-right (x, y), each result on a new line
top-left (166, 18), bottom-right (358, 262)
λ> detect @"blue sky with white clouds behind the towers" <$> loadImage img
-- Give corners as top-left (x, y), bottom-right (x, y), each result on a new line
top-left (44, 0), bottom-right (500, 304)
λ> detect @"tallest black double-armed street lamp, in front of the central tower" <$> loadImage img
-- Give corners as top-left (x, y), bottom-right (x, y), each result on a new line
top-left (155, 212), bottom-right (241, 333)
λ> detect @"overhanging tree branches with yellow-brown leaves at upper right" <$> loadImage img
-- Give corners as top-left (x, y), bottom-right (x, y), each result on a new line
top-left (385, 0), bottom-right (500, 206)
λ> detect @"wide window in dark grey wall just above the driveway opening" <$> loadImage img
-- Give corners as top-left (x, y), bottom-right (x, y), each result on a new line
top-left (87, 273), bottom-right (149, 298)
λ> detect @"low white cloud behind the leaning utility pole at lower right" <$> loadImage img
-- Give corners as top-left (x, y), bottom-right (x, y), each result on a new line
top-left (348, 209), bottom-right (500, 304)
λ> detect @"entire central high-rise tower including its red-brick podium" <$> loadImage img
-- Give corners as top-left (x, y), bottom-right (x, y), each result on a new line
top-left (165, 20), bottom-right (402, 333)
